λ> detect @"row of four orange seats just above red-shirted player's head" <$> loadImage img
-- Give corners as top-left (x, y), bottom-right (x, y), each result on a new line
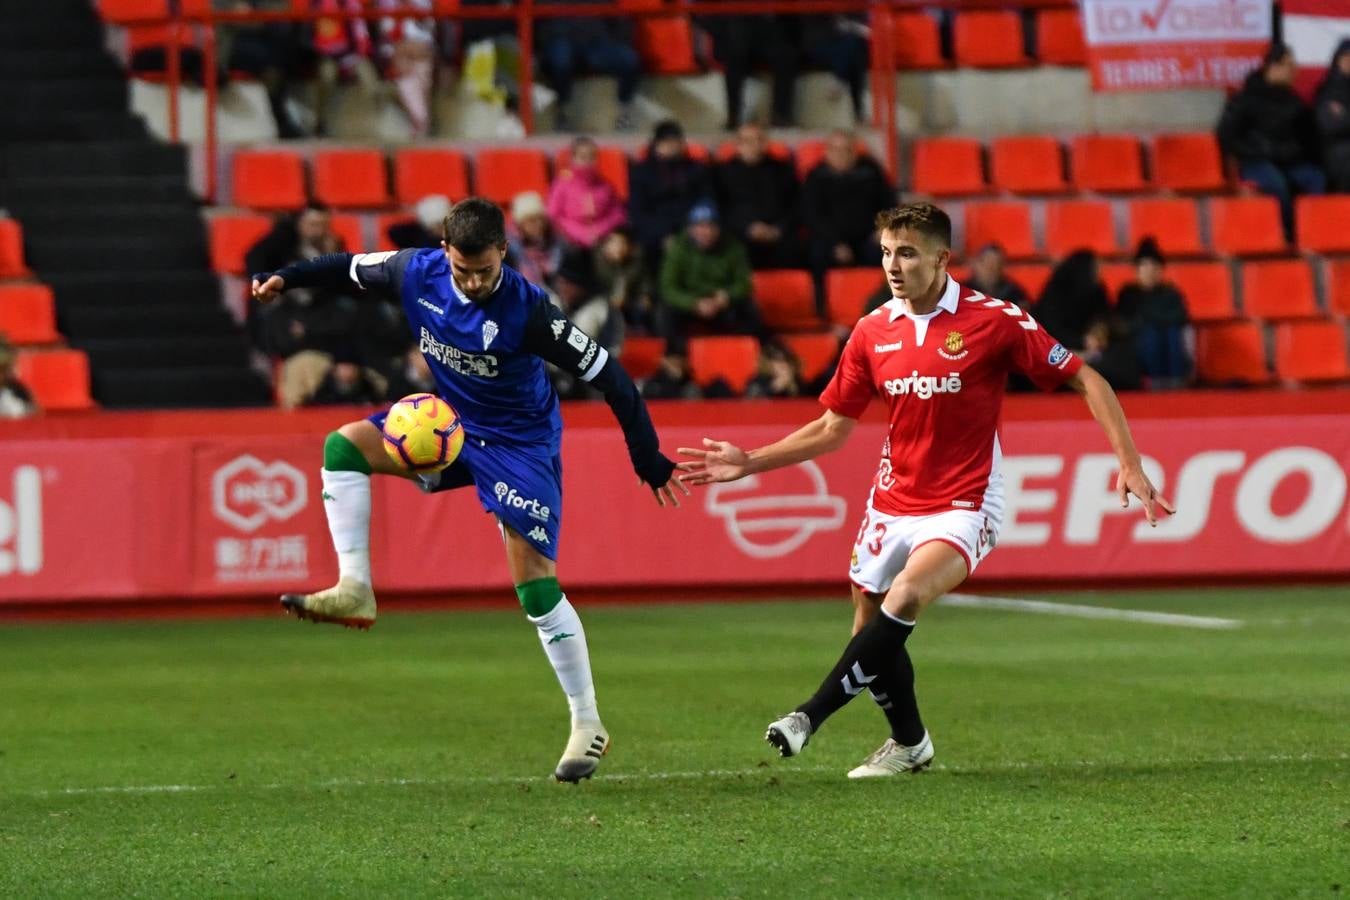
top-left (913, 132), bottom-right (1229, 197)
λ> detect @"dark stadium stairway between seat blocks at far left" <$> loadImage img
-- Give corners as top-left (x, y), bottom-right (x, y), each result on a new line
top-left (0, 0), bottom-right (271, 407)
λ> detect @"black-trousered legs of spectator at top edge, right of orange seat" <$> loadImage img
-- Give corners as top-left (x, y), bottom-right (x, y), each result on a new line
top-left (701, 15), bottom-right (802, 131)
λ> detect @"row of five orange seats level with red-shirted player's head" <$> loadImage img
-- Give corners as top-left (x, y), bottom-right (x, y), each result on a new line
top-left (952, 194), bottom-right (1350, 260)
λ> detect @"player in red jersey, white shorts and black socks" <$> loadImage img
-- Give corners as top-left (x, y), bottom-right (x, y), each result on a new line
top-left (680, 204), bottom-right (1175, 779)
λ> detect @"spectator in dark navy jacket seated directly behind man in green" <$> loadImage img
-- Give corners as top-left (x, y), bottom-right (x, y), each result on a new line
top-left (628, 119), bottom-right (713, 266)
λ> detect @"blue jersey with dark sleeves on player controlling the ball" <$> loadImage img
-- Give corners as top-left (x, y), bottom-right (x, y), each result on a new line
top-left (351, 250), bottom-right (608, 452)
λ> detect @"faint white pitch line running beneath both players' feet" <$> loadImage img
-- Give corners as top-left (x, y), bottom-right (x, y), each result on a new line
top-left (13, 753), bottom-right (1350, 797)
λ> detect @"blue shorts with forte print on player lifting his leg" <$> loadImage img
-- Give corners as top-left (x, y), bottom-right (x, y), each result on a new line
top-left (367, 413), bottom-right (563, 563)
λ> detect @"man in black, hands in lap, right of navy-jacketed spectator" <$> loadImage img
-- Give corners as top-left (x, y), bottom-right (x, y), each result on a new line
top-left (713, 124), bottom-right (802, 269)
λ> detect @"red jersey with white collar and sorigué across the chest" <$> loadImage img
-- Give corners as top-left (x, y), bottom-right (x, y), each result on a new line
top-left (821, 278), bottom-right (1083, 515)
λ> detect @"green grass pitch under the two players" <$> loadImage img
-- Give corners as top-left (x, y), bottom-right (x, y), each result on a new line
top-left (0, 587), bottom-right (1350, 900)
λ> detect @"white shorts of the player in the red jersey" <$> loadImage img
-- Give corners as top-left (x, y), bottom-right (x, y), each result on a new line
top-left (848, 490), bottom-right (1003, 594)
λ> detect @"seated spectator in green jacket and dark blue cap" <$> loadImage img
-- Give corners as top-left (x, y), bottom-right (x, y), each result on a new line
top-left (662, 202), bottom-right (764, 351)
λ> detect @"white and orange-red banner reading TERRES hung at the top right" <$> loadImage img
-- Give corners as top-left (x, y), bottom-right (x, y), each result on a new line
top-left (1080, 0), bottom-right (1272, 90)
